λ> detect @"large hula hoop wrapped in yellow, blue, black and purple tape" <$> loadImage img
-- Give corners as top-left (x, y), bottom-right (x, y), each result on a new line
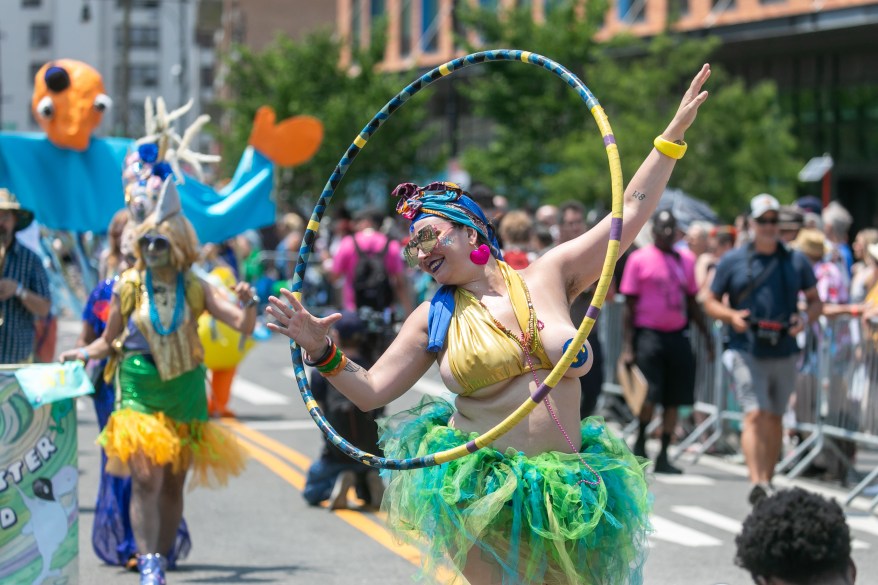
top-left (290, 49), bottom-right (623, 469)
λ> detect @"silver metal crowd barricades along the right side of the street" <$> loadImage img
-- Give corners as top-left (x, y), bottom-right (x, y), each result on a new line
top-left (598, 295), bottom-right (878, 509)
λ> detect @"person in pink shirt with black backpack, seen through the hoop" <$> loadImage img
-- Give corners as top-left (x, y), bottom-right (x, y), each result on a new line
top-left (332, 208), bottom-right (414, 350)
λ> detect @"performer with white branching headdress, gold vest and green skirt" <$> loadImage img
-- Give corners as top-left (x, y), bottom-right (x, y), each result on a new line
top-left (60, 107), bottom-right (259, 585)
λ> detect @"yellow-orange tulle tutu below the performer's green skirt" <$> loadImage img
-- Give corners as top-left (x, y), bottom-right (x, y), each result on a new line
top-left (98, 408), bottom-right (247, 490)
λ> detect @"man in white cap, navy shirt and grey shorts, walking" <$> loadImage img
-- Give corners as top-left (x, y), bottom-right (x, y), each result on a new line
top-left (704, 193), bottom-right (822, 504)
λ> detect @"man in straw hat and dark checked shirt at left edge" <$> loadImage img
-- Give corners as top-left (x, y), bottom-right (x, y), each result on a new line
top-left (0, 189), bottom-right (51, 364)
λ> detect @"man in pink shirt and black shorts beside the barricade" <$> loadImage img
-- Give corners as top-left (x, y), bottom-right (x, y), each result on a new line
top-left (619, 210), bottom-right (710, 474)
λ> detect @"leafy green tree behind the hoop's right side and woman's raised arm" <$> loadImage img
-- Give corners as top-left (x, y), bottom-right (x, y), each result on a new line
top-left (463, 2), bottom-right (802, 218)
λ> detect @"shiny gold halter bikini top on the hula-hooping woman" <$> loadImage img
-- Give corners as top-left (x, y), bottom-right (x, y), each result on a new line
top-left (448, 262), bottom-right (553, 396)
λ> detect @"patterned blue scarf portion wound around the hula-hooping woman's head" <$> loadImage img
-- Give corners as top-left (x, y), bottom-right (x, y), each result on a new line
top-left (391, 181), bottom-right (503, 260)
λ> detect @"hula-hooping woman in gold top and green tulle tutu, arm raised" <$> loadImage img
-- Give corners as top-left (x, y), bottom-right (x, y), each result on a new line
top-left (268, 59), bottom-right (710, 585)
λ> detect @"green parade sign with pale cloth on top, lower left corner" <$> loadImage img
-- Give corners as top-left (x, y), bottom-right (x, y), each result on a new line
top-left (0, 362), bottom-right (90, 585)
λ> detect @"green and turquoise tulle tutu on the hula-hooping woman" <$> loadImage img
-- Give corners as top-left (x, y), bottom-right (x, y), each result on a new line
top-left (380, 397), bottom-right (652, 585)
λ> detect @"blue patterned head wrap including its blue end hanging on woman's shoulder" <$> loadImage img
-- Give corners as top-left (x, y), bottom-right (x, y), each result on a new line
top-left (392, 181), bottom-right (503, 353)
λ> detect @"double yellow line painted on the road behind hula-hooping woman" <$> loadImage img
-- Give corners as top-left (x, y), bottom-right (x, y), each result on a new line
top-left (222, 418), bottom-right (457, 583)
